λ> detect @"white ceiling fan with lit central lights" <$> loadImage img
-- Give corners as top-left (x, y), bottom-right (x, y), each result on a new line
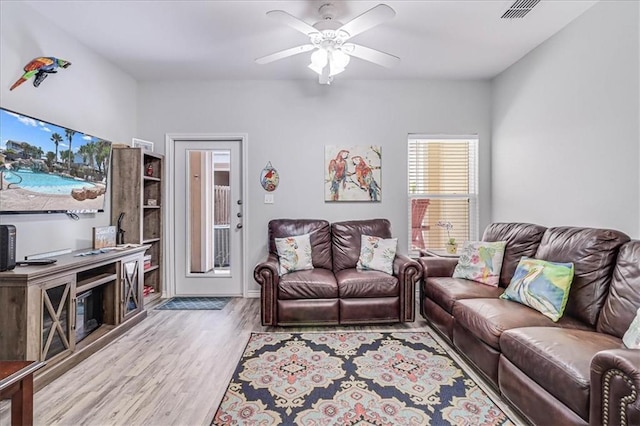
top-left (256, 3), bottom-right (400, 84)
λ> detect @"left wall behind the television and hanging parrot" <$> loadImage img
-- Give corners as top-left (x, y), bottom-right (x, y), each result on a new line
top-left (0, 1), bottom-right (137, 259)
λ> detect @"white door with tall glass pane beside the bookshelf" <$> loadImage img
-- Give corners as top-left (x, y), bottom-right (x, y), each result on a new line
top-left (173, 139), bottom-right (243, 296)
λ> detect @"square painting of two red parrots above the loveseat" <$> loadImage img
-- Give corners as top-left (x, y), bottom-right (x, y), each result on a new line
top-left (324, 145), bottom-right (382, 202)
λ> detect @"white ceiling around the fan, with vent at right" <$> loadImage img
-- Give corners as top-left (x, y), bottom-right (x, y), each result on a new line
top-left (26, 0), bottom-right (596, 81)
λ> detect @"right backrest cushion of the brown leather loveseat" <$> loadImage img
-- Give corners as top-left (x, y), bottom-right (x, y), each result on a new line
top-left (331, 219), bottom-right (391, 272)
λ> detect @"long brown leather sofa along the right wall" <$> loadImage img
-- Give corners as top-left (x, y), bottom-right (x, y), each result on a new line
top-left (419, 223), bottom-right (640, 425)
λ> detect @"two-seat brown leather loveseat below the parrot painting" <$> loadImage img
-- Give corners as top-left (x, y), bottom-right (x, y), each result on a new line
top-left (253, 219), bottom-right (422, 326)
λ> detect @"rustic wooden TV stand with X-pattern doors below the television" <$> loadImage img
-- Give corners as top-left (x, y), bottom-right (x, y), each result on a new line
top-left (0, 245), bottom-right (149, 390)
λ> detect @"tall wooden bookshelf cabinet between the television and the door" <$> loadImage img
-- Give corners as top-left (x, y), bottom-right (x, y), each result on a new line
top-left (111, 147), bottom-right (164, 303)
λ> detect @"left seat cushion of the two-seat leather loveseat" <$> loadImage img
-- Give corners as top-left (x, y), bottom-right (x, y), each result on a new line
top-left (278, 268), bottom-right (338, 300)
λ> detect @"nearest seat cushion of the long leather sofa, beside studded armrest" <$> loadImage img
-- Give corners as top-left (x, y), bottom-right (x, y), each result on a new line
top-left (500, 327), bottom-right (622, 419)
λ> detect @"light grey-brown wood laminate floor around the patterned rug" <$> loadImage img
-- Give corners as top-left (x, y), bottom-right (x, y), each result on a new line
top-left (0, 298), bottom-right (516, 426)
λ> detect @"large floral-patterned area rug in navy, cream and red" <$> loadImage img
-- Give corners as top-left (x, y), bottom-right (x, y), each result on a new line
top-left (212, 332), bottom-right (514, 425)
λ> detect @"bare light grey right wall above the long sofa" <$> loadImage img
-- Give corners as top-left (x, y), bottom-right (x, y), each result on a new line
top-left (491, 1), bottom-right (640, 238)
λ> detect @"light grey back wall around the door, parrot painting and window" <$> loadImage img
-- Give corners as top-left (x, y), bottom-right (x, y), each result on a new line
top-left (138, 76), bottom-right (491, 289)
